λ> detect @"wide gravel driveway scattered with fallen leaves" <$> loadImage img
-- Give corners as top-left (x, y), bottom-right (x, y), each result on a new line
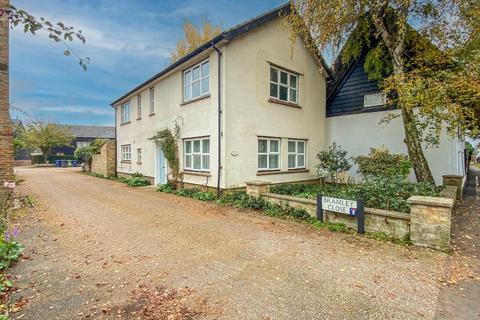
top-left (13, 168), bottom-right (446, 320)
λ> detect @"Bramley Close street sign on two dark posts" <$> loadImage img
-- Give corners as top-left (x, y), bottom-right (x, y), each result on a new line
top-left (317, 194), bottom-right (365, 234)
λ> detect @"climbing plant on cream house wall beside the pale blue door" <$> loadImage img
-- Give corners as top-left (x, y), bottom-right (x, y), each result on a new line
top-left (153, 124), bottom-right (180, 182)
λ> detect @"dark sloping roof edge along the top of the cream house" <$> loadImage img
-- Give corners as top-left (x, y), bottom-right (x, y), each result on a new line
top-left (110, 2), bottom-right (330, 106)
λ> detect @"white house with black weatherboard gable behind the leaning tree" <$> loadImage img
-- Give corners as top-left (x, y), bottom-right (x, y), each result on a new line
top-left (326, 33), bottom-right (466, 185)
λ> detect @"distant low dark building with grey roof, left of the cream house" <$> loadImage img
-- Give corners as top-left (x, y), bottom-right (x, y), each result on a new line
top-left (52, 124), bottom-right (115, 156)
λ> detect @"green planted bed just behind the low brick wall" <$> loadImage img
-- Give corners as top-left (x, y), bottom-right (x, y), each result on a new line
top-left (270, 177), bottom-right (439, 213)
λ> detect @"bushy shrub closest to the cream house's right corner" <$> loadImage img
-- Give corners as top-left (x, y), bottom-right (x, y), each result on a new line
top-left (317, 142), bottom-right (352, 182)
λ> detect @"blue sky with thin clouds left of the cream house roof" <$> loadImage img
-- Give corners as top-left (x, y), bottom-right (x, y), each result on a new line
top-left (10, 0), bottom-right (285, 125)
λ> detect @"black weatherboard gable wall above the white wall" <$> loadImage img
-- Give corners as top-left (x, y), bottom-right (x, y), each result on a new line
top-left (327, 55), bottom-right (387, 117)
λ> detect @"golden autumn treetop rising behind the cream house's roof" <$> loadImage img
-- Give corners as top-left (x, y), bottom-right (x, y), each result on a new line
top-left (170, 20), bottom-right (222, 63)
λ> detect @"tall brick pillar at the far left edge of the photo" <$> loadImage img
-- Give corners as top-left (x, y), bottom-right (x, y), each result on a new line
top-left (0, 0), bottom-right (13, 182)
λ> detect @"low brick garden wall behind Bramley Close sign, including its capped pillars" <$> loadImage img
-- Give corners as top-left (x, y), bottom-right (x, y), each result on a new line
top-left (246, 181), bottom-right (459, 251)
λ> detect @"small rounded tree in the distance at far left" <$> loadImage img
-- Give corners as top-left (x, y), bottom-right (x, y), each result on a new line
top-left (21, 122), bottom-right (73, 162)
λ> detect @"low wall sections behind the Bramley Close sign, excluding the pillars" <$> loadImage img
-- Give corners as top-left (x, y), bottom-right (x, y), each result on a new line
top-left (261, 193), bottom-right (410, 240)
